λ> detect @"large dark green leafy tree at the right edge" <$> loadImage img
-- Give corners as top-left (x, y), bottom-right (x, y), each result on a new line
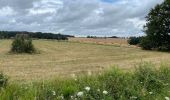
top-left (140, 0), bottom-right (170, 51)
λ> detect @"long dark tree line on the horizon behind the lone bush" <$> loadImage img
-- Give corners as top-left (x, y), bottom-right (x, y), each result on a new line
top-left (0, 31), bottom-right (74, 40)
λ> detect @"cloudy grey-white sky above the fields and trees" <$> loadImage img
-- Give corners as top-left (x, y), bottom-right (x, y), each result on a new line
top-left (0, 0), bottom-right (163, 37)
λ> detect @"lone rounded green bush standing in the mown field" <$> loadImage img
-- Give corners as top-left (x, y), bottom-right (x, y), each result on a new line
top-left (11, 34), bottom-right (35, 53)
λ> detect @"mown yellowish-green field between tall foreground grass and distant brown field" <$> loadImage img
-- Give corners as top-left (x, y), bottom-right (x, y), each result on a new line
top-left (0, 40), bottom-right (170, 81)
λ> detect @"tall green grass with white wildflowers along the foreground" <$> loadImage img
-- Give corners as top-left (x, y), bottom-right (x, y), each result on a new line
top-left (0, 63), bottom-right (170, 100)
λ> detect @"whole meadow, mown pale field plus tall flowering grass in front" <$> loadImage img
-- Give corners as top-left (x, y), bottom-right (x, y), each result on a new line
top-left (0, 39), bottom-right (170, 100)
